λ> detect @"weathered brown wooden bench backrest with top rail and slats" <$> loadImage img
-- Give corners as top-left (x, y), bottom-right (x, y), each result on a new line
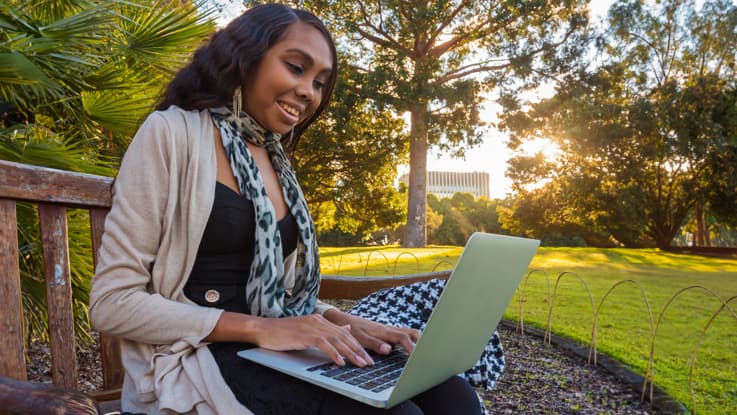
top-left (0, 160), bottom-right (123, 389)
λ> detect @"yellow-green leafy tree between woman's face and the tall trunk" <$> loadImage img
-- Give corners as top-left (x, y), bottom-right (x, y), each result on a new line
top-left (292, 58), bottom-right (406, 241)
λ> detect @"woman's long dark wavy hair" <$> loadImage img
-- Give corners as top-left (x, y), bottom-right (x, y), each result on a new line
top-left (156, 4), bottom-right (338, 148)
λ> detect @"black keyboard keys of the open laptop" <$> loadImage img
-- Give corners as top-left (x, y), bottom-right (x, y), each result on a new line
top-left (307, 348), bottom-right (409, 392)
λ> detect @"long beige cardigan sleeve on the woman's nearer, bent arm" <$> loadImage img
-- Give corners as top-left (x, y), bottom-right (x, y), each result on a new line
top-left (90, 110), bottom-right (222, 344)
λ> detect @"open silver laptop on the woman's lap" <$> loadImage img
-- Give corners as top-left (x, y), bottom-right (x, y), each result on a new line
top-left (238, 232), bottom-right (540, 408)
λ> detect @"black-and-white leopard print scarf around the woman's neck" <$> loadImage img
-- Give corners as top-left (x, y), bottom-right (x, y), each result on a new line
top-left (210, 107), bottom-right (320, 317)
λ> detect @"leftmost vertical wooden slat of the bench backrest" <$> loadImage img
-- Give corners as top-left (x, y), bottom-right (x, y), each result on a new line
top-left (0, 199), bottom-right (26, 380)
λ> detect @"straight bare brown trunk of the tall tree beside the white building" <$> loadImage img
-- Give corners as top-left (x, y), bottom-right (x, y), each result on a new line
top-left (402, 104), bottom-right (427, 248)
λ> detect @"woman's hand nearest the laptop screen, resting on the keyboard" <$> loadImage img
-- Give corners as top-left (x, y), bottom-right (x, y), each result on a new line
top-left (324, 309), bottom-right (420, 354)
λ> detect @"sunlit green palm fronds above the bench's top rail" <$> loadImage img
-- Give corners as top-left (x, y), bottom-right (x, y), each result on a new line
top-left (0, 0), bottom-right (213, 153)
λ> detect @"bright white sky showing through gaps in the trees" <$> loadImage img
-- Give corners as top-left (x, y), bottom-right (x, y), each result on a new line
top-left (218, 0), bottom-right (614, 199)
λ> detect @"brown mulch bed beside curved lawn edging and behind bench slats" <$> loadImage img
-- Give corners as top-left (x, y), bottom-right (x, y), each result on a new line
top-left (28, 326), bottom-right (656, 415)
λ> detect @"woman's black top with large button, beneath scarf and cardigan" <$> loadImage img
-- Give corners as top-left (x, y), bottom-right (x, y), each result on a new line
top-left (184, 182), bottom-right (298, 313)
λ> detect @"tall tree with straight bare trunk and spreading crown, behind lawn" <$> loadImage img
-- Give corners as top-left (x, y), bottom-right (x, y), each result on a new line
top-left (299, 0), bottom-right (587, 247)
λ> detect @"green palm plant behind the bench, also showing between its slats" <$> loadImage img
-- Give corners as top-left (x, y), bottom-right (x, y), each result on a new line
top-left (0, 0), bottom-right (214, 340)
